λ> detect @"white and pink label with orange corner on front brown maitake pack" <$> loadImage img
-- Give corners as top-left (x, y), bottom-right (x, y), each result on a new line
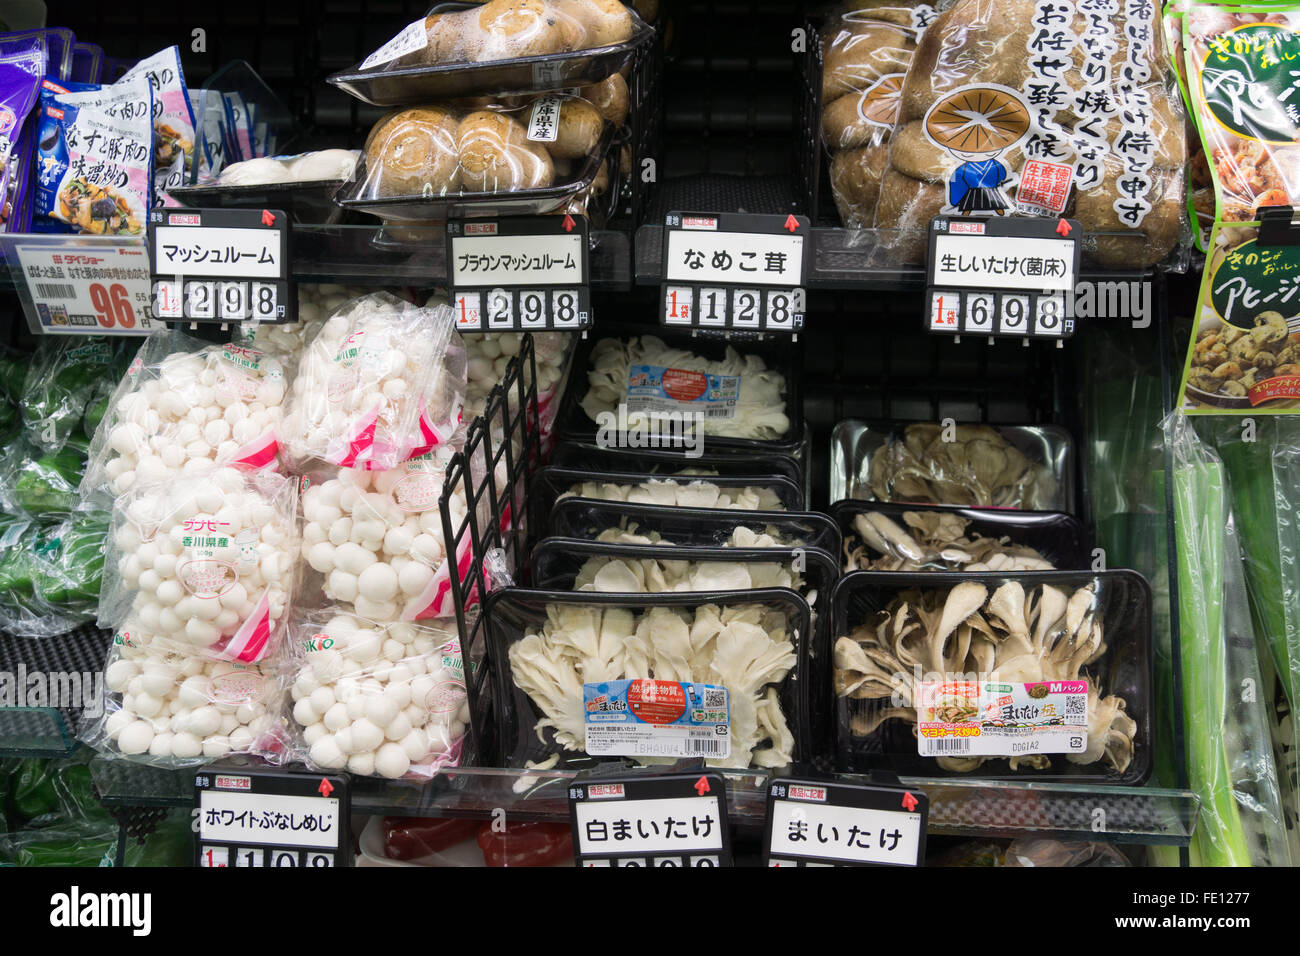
top-left (917, 680), bottom-right (1088, 757)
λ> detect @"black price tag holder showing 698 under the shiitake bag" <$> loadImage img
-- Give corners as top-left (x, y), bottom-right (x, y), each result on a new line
top-left (926, 216), bottom-right (1083, 339)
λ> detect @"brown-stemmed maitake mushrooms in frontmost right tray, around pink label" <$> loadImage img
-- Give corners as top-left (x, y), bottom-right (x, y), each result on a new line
top-left (835, 581), bottom-right (1138, 773)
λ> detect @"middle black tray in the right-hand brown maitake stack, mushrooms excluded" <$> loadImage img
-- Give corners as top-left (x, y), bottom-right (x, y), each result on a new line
top-left (831, 498), bottom-right (1092, 574)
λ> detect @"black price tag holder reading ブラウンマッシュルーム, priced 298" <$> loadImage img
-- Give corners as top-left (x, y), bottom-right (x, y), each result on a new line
top-left (447, 215), bottom-right (592, 332)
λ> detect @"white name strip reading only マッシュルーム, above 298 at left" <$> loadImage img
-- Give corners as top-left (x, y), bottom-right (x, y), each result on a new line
top-left (153, 225), bottom-right (282, 280)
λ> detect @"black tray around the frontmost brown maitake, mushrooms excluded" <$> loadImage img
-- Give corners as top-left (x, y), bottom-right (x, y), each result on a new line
top-left (826, 570), bottom-right (1156, 787)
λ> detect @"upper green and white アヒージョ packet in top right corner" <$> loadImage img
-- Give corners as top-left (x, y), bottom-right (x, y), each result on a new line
top-left (1182, 3), bottom-right (1300, 222)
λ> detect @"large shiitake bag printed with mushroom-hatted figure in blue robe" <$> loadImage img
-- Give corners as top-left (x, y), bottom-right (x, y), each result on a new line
top-left (875, 0), bottom-right (1186, 268)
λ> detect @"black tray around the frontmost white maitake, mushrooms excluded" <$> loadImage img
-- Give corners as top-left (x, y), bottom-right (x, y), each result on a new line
top-left (484, 588), bottom-right (809, 770)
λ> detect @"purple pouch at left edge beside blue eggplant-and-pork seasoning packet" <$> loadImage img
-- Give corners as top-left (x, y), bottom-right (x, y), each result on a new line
top-left (0, 30), bottom-right (47, 233)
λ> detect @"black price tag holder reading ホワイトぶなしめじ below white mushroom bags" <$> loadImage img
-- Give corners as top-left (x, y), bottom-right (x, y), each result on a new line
top-left (194, 766), bottom-right (352, 868)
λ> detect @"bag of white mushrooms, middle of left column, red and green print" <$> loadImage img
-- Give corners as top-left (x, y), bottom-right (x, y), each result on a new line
top-left (99, 467), bottom-right (299, 662)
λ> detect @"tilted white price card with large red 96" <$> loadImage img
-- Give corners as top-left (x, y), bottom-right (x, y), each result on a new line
top-left (5, 235), bottom-right (161, 336)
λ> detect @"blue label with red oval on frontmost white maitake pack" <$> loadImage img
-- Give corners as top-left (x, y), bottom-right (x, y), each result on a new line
top-left (582, 679), bottom-right (731, 760)
